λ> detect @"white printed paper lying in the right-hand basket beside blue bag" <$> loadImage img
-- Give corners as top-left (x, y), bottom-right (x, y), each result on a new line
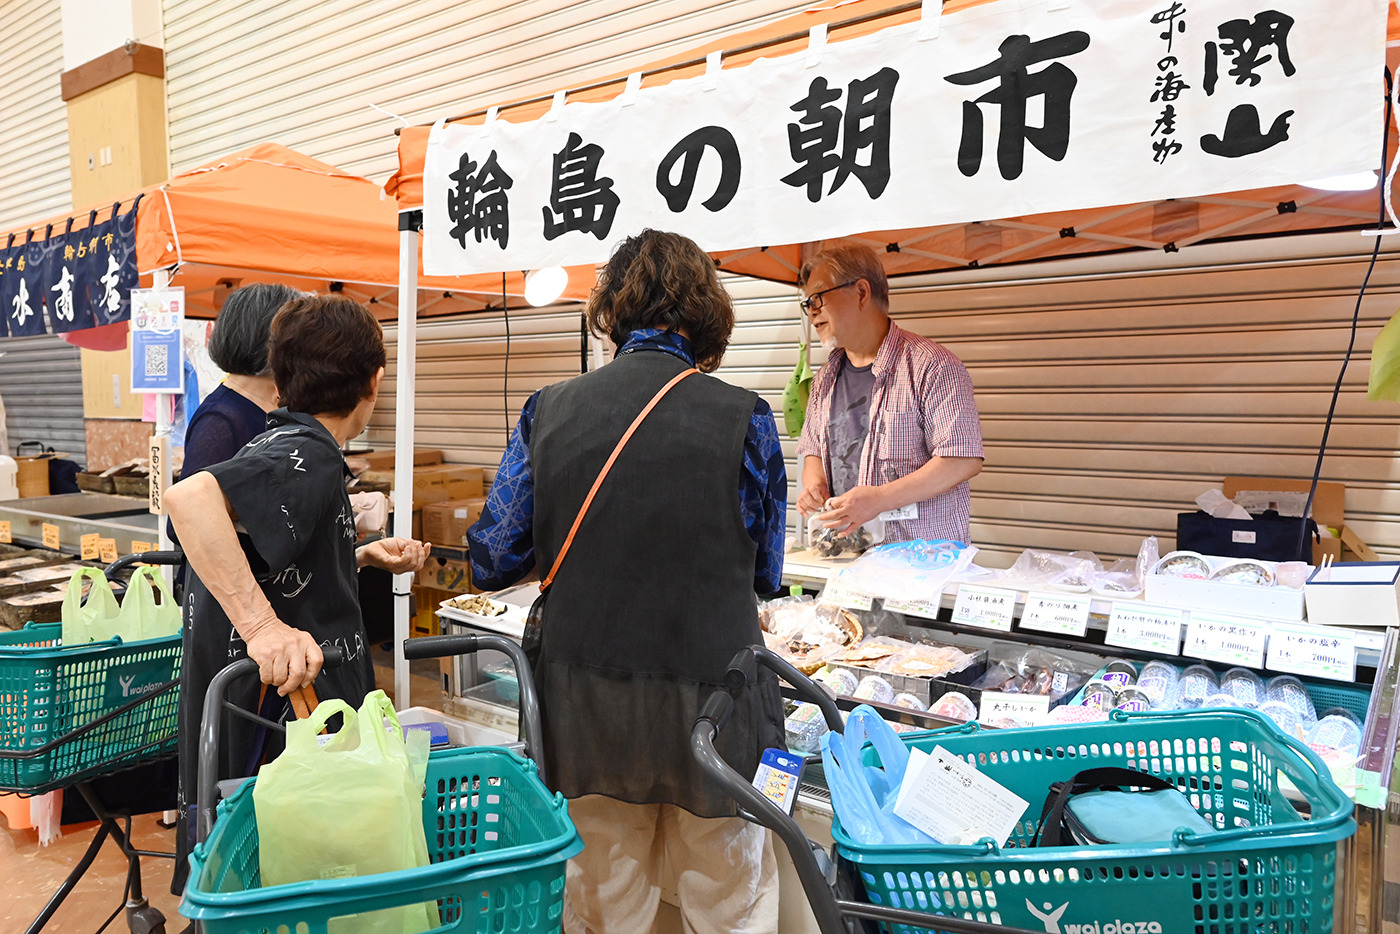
top-left (895, 746), bottom-right (1028, 846)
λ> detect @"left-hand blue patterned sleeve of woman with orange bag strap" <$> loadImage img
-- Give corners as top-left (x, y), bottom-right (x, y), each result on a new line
top-left (466, 392), bottom-right (539, 591)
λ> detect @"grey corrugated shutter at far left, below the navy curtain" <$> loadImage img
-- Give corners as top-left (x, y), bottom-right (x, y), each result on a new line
top-left (0, 335), bottom-right (87, 463)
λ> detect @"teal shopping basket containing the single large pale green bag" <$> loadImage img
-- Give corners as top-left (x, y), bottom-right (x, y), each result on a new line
top-left (181, 746), bottom-right (584, 934)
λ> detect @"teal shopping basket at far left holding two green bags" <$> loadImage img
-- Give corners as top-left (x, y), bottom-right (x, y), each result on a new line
top-left (0, 623), bottom-right (181, 793)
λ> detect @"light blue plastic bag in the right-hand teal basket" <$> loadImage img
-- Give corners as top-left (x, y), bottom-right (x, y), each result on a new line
top-left (822, 704), bottom-right (937, 844)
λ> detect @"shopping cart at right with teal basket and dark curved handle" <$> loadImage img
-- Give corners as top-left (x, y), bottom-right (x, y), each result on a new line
top-left (690, 646), bottom-right (1357, 934)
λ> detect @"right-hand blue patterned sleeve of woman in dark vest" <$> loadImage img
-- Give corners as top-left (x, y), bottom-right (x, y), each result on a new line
top-left (739, 399), bottom-right (787, 594)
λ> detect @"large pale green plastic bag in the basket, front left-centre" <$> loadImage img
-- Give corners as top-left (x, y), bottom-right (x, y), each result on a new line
top-left (253, 690), bottom-right (438, 934)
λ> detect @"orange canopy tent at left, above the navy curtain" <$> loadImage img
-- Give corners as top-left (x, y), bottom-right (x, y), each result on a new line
top-left (0, 143), bottom-right (580, 330)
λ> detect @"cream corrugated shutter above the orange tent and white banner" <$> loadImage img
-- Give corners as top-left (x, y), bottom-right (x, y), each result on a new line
top-left (163, 0), bottom-right (808, 178)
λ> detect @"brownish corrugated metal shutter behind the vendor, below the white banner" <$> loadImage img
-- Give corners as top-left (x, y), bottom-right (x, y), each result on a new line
top-left (371, 234), bottom-right (1400, 564)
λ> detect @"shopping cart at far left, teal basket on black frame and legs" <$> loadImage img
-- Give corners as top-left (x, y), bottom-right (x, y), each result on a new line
top-left (0, 552), bottom-right (183, 934)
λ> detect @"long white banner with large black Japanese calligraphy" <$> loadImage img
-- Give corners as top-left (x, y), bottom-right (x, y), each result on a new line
top-left (423, 0), bottom-right (1386, 274)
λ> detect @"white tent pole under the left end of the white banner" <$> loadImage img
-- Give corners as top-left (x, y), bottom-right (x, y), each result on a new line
top-left (393, 211), bottom-right (423, 710)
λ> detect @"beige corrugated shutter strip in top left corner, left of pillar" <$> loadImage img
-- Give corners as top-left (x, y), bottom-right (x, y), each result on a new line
top-left (0, 0), bottom-right (73, 230)
